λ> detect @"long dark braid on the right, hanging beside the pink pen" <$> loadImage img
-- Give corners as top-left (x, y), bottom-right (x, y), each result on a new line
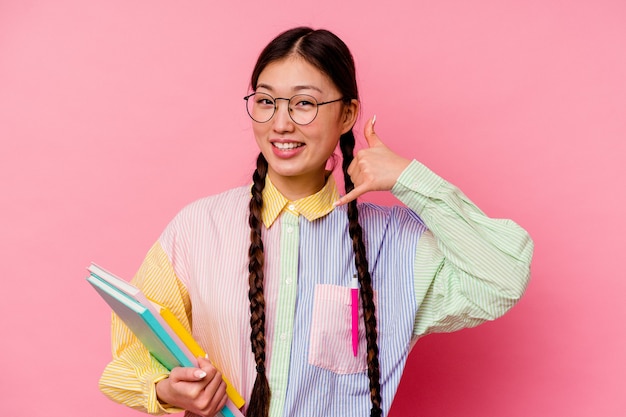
top-left (339, 130), bottom-right (382, 417)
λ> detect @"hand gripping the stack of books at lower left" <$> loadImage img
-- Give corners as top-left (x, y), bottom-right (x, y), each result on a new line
top-left (156, 358), bottom-right (228, 417)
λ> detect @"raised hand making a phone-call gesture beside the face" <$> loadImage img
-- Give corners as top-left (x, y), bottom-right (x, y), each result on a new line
top-left (335, 116), bottom-right (411, 206)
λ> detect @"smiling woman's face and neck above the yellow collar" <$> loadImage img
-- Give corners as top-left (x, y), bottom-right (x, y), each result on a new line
top-left (252, 57), bottom-right (358, 198)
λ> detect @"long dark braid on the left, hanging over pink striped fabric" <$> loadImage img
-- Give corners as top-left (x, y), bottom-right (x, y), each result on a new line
top-left (247, 153), bottom-right (271, 417)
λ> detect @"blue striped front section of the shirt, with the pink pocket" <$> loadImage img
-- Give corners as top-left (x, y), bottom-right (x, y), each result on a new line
top-left (271, 204), bottom-right (425, 417)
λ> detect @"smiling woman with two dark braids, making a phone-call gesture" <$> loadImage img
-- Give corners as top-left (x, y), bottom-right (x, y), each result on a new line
top-left (101, 28), bottom-right (533, 417)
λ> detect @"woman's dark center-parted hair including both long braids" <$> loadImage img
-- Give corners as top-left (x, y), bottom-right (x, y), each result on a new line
top-left (247, 27), bottom-right (382, 417)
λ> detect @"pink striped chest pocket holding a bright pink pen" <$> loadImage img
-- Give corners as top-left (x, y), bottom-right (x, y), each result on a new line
top-left (309, 284), bottom-right (377, 374)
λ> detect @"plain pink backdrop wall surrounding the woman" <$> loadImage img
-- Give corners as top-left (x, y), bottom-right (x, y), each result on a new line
top-left (0, 0), bottom-right (626, 417)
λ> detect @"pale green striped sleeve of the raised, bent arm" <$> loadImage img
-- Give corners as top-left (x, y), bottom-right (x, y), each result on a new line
top-left (392, 161), bottom-right (533, 336)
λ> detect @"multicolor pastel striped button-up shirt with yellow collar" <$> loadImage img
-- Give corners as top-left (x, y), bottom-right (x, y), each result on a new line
top-left (100, 161), bottom-right (533, 417)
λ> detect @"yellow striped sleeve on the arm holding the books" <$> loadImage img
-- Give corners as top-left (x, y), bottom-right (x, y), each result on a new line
top-left (100, 242), bottom-right (191, 415)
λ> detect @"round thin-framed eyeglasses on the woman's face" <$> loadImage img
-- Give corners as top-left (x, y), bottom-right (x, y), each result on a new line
top-left (243, 93), bottom-right (344, 126)
